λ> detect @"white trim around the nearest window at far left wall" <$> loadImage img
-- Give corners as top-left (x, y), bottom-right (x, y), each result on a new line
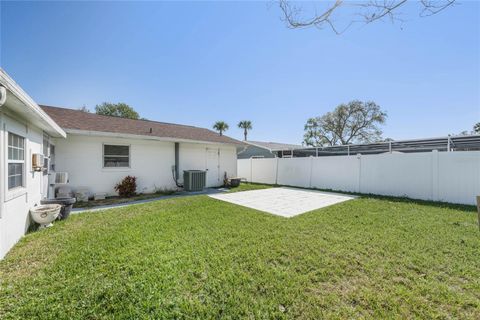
top-left (4, 129), bottom-right (28, 202)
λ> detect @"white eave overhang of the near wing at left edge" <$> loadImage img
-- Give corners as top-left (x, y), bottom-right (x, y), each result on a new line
top-left (0, 68), bottom-right (67, 138)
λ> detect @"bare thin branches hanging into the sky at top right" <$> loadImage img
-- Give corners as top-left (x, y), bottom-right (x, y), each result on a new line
top-left (278, 0), bottom-right (456, 34)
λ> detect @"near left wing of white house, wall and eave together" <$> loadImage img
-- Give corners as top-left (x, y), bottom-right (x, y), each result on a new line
top-left (0, 68), bottom-right (66, 259)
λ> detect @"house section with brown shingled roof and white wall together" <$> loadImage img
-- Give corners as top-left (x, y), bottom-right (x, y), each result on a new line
top-left (42, 106), bottom-right (240, 195)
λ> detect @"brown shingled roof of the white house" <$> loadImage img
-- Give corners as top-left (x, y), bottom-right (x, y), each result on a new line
top-left (40, 105), bottom-right (241, 144)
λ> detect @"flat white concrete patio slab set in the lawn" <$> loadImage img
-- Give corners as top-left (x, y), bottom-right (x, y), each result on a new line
top-left (209, 187), bottom-right (356, 218)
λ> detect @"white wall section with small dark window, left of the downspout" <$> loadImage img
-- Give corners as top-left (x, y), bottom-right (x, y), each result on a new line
top-left (55, 134), bottom-right (175, 195)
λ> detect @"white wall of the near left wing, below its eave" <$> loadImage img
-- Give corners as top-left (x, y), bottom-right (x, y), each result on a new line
top-left (0, 112), bottom-right (46, 259)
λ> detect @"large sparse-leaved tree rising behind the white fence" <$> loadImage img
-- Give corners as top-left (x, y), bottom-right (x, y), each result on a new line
top-left (303, 100), bottom-right (387, 146)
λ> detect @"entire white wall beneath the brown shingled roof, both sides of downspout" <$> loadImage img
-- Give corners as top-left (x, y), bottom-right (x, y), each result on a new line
top-left (55, 134), bottom-right (237, 195)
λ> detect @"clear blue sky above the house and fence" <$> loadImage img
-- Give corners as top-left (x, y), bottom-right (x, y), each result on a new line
top-left (0, 1), bottom-right (480, 143)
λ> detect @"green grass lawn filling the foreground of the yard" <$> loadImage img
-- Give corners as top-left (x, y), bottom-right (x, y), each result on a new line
top-left (0, 191), bottom-right (480, 319)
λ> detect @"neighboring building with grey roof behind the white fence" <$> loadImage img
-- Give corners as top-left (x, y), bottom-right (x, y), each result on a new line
top-left (237, 141), bottom-right (303, 159)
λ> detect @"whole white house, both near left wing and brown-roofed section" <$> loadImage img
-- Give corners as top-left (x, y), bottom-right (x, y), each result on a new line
top-left (0, 69), bottom-right (240, 259)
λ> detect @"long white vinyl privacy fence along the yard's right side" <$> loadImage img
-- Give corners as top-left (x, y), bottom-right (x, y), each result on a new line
top-left (238, 151), bottom-right (480, 204)
